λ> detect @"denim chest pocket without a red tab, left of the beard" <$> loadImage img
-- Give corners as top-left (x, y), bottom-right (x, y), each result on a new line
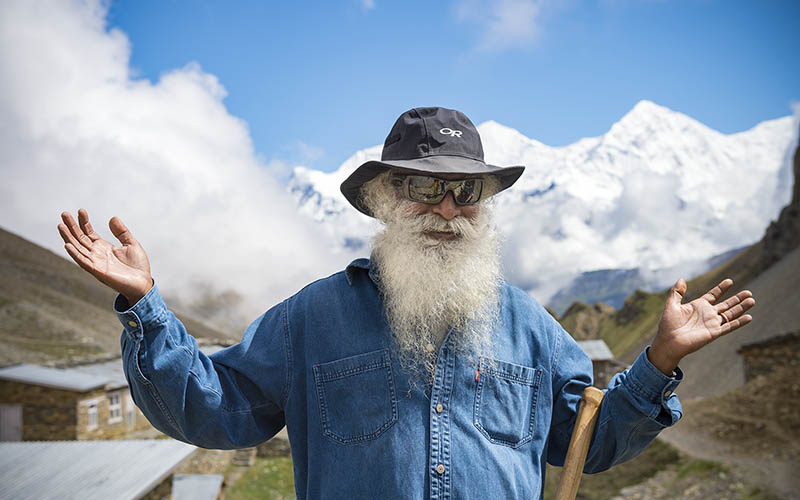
top-left (314, 349), bottom-right (397, 444)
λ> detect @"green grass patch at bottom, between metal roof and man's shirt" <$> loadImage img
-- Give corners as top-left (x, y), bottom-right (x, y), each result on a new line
top-left (225, 457), bottom-right (295, 500)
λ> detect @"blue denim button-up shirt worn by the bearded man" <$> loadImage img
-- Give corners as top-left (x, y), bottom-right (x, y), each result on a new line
top-left (115, 259), bottom-right (682, 499)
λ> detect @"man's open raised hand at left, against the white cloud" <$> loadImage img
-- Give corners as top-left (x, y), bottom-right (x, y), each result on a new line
top-left (58, 209), bottom-right (153, 306)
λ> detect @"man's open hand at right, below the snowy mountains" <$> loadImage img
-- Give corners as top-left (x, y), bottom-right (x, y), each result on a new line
top-left (647, 279), bottom-right (756, 375)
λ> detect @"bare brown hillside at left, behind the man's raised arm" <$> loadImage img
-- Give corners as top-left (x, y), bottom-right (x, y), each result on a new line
top-left (0, 228), bottom-right (235, 366)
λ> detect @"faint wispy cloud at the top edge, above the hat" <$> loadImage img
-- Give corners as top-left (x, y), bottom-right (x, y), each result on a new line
top-left (455, 0), bottom-right (545, 51)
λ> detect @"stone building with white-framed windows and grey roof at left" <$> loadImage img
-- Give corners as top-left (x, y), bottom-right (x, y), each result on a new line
top-left (0, 359), bottom-right (152, 441)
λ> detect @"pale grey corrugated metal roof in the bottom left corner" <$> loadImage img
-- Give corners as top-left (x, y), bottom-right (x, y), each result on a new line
top-left (0, 439), bottom-right (196, 500)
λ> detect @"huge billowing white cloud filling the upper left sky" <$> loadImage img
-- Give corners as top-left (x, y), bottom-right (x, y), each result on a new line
top-left (0, 0), bottom-right (346, 326)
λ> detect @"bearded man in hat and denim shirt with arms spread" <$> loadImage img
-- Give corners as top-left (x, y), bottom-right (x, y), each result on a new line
top-left (59, 108), bottom-right (755, 499)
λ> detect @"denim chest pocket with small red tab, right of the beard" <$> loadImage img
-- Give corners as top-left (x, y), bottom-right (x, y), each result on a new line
top-left (474, 358), bottom-right (542, 448)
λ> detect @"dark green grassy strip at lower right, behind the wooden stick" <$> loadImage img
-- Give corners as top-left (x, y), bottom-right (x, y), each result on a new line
top-left (544, 440), bottom-right (680, 500)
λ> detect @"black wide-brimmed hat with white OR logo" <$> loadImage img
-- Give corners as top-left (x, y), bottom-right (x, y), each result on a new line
top-left (341, 108), bottom-right (525, 217)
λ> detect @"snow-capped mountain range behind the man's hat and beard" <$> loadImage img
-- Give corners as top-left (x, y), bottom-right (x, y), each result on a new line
top-left (288, 101), bottom-right (798, 302)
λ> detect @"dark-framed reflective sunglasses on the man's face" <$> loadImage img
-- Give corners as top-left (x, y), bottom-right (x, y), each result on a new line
top-left (392, 174), bottom-right (483, 205)
